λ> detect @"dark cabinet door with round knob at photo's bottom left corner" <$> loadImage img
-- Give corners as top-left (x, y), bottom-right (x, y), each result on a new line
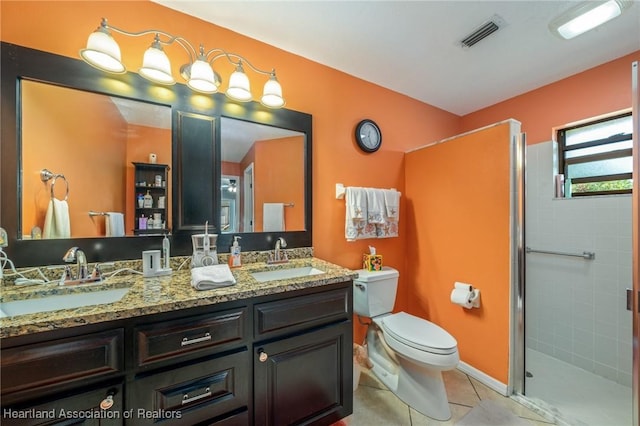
top-left (1, 383), bottom-right (124, 426)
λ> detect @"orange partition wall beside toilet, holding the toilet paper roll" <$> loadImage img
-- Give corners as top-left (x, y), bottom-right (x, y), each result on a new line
top-left (405, 123), bottom-right (510, 383)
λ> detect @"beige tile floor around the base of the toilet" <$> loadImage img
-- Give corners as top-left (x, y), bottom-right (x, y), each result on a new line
top-left (344, 370), bottom-right (554, 426)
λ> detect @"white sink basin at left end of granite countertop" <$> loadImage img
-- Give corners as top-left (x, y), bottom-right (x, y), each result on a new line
top-left (0, 287), bottom-right (129, 318)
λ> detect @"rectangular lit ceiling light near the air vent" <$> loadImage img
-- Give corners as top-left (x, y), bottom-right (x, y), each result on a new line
top-left (549, 0), bottom-right (633, 40)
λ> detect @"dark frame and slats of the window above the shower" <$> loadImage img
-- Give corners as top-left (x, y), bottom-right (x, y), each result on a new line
top-left (556, 111), bottom-right (633, 198)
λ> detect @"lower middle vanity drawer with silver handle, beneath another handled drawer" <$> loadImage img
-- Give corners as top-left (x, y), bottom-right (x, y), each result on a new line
top-left (128, 349), bottom-right (251, 425)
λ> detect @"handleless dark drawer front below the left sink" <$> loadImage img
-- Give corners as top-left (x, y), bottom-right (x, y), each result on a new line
top-left (1, 329), bottom-right (124, 395)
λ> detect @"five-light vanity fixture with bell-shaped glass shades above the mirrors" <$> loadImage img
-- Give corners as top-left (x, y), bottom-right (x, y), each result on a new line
top-left (80, 18), bottom-right (285, 108)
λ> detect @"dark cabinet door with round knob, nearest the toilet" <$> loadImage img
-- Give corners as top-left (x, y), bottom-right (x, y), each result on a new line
top-left (253, 321), bottom-right (353, 425)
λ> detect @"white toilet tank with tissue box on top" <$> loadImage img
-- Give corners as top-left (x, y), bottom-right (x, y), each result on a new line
top-left (353, 266), bottom-right (400, 318)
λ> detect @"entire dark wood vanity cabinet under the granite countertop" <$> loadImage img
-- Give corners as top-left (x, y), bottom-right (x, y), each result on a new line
top-left (0, 281), bottom-right (353, 426)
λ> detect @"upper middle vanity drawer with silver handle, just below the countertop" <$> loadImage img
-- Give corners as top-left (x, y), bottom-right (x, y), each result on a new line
top-left (135, 307), bottom-right (247, 366)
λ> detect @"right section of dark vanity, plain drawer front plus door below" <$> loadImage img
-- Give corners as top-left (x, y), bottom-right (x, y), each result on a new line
top-left (253, 281), bottom-right (353, 426)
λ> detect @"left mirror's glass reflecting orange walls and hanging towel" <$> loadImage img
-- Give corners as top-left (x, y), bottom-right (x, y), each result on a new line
top-left (19, 80), bottom-right (172, 239)
